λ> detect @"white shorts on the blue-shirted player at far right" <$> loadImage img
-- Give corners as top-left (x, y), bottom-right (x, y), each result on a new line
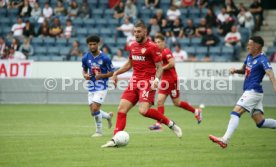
top-left (237, 90), bottom-right (264, 115)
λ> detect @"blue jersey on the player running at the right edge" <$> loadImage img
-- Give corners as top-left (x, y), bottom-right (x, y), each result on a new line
top-left (243, 53), bottom-right (272, 93)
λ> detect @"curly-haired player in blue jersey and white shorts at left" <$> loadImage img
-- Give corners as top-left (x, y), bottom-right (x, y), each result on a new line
top-left (82, 36), bottom-right (115, 137)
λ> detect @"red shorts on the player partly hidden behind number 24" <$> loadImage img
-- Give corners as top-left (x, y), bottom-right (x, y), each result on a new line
top-left (158, 80), bottom-right (179, 99)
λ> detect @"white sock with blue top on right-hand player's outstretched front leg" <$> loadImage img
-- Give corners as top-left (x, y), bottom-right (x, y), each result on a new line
top-left (222, 111), bottom-right (240, 143)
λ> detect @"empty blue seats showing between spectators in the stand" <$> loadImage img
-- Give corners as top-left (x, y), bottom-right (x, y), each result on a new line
top-left (0, 0), bottom-right (276, 61)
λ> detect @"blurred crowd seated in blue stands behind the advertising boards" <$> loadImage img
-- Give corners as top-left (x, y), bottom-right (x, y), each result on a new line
top-left (0, 0), bottom-right (270, 62)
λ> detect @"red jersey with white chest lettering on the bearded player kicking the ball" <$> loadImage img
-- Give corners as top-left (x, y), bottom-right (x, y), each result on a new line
top-left (129, 39), bottom-right (162, 82)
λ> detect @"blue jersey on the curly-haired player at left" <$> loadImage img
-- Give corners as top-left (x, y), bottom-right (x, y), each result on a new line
top-left (82, 52), bottom-right (115, 92)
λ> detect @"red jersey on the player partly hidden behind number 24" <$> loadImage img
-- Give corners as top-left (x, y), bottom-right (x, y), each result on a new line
top-left (162, 48), bottom-right (177, 82)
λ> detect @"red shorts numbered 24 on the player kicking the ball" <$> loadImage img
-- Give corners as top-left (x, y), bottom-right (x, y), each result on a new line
top-left (121, 83), bottom-right (156, 105)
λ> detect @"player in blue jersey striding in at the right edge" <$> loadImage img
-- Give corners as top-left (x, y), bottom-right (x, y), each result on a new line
top-left (209, 36), bottom-right (276, 148)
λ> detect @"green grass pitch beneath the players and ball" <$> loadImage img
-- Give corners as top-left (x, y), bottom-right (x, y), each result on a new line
top-left (0, 104), bottom-right (276, 167)
